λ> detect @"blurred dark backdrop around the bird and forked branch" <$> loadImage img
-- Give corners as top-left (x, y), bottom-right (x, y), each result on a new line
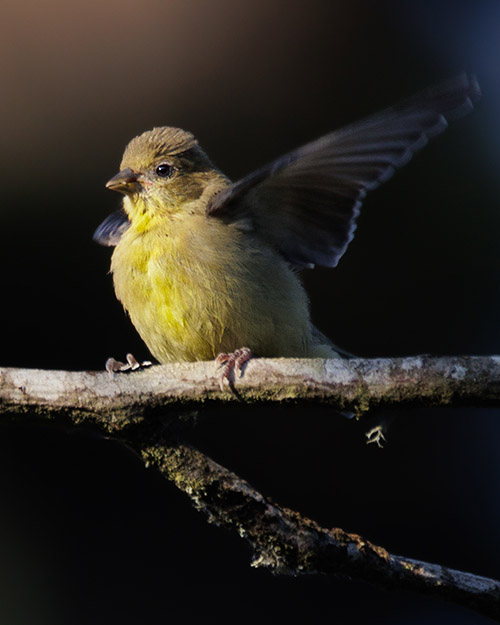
top-left (0, 0), bottom-right (500, 625)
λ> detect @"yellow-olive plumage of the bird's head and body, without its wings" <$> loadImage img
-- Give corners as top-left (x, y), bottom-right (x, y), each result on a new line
top-left (104, 128), bottom-right (337, 362)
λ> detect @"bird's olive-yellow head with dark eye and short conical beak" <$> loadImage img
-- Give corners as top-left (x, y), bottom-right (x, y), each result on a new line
top-left (106, 126), bottom-right (228, 223)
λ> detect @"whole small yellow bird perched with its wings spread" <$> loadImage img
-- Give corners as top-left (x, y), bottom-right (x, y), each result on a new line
top-left (94, 74), bottom-right (481, 378)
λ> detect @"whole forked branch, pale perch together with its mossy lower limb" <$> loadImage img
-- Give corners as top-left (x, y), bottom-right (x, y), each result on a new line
top-left (0, 356), bottom-right (500, 621)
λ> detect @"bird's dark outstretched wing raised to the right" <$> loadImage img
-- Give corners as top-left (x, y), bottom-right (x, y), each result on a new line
top-left (207, 74), bottom-right (481, 267)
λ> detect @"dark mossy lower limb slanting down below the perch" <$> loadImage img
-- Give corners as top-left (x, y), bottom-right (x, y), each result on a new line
top-left (142, 443), bottom-right (500, 620)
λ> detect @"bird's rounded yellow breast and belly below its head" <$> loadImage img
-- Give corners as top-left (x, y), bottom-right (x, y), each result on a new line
top-left (111, 215), bottom-right (311, 362)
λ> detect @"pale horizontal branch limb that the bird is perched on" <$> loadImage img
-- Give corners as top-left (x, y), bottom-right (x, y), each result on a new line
top-left (0, 356), bottom-right (500, 432)
